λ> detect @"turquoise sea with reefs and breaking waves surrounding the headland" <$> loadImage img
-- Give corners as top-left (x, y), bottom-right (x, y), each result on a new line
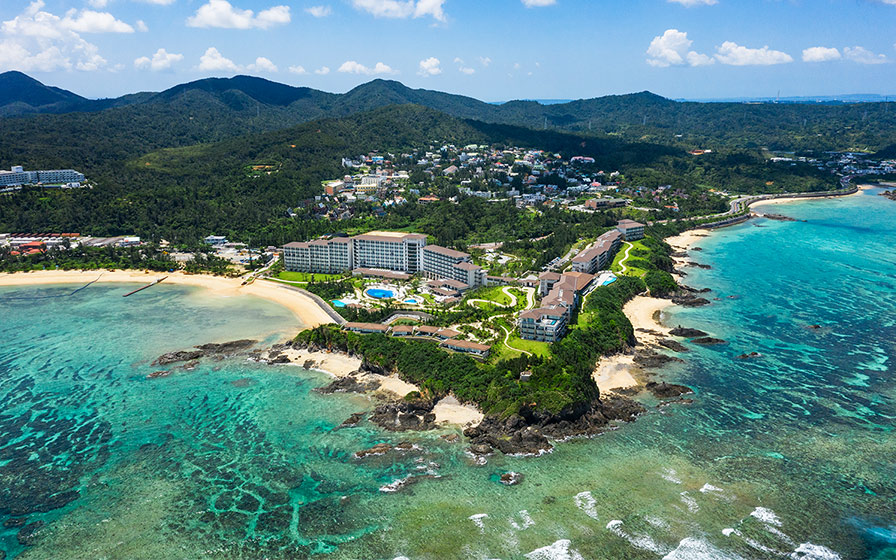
top-left (0, 190), bottom-right (896, 560)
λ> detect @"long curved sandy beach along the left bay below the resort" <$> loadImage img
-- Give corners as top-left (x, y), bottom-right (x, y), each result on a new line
top-left (0, 270), bottom-right (333, 328)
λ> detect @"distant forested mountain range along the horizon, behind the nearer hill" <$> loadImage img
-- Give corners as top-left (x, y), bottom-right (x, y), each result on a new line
top-left (0, 72), bottom-right (896, 155)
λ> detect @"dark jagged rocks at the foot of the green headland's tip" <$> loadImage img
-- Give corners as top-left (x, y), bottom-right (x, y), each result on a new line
top-left (464, 395), bottom-right (645, 455)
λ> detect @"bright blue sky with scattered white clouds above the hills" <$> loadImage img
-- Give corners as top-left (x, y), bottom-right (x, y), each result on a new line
top-left (0, 0), bottom-right (896, 101)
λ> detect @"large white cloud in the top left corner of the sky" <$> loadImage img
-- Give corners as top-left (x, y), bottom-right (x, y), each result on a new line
top-left (0, 0), bottom-right (108, 72)
